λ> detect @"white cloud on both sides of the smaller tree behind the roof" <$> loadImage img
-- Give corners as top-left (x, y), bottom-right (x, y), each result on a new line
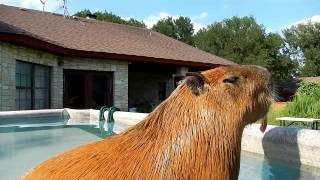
top-left (143, 12), bottom-right (208, 33)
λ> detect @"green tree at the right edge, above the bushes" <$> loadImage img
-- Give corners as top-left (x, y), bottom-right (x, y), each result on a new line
top-left (283, 23), bottom-right (320, 76)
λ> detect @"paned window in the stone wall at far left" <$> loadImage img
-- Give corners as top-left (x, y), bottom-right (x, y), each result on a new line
top-left (16, 61), bottom-right (50, 110)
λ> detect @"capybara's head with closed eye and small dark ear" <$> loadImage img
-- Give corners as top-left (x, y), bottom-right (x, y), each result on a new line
top-left (180, 65), bottom-right (273, 129)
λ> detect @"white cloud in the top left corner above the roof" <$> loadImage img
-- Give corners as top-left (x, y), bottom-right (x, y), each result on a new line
top-left (0, 0), bottom-right (62, 12)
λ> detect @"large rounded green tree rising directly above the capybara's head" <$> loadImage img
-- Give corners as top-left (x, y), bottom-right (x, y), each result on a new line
top-left (195, 17), bottom-right (264, 64)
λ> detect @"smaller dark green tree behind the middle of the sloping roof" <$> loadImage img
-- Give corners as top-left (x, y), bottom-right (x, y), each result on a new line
top-left (152, 16), bottom-right (194, 45)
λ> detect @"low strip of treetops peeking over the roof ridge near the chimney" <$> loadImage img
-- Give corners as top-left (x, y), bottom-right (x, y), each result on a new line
top-left (74, 9), bottom-right (146, 28)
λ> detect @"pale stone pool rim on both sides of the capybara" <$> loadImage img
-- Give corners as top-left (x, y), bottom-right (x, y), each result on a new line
top-left (0, 108), bottom-right (320, 168)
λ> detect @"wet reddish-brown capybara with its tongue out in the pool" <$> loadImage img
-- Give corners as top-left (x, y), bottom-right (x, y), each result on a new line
top-left (24, 65), bottom-right (273, 180)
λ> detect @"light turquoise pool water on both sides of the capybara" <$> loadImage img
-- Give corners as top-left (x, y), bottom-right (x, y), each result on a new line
top-left (0, 117), bottom-right (320, 180)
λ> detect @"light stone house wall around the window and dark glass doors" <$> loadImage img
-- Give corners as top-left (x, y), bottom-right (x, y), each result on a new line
top-left (0, 42), bottom-right (128, 111)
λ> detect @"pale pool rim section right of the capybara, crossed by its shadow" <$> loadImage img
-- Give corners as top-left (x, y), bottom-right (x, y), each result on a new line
top-left (241, 124), bottom-right (320, 168)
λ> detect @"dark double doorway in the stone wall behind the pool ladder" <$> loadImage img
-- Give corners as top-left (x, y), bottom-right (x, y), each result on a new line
top-left (63, 70), bottom-right (113, 109)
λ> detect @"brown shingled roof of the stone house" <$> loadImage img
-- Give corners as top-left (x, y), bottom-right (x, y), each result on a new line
top-left (0, 5), bottom-right (235, 67)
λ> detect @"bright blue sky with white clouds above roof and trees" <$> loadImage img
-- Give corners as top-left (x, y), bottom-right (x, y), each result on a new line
top-left (0, 0), bottom-right (320, 32)
